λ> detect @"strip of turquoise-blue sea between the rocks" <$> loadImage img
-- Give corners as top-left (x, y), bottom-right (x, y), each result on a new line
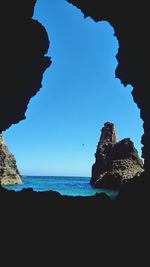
top-left (4, 176), bottom-right (118, 199)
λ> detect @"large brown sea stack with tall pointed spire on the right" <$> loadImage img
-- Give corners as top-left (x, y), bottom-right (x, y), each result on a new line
top-left (90, 122), bottom-right (144, 189)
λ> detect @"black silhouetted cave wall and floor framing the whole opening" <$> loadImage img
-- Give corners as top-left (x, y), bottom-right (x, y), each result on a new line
top-left (0, 0), bottom-right (150, 256)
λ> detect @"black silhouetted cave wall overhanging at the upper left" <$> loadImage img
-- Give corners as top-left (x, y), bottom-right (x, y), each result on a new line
top-left (0, 0), bottom-right (51, 132)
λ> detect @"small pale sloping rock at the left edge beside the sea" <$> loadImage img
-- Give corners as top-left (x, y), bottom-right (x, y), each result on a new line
top-left (0, 134), bottom-right (22, 185)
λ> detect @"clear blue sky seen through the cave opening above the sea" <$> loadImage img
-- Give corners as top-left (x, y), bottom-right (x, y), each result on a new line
top-left (3, 0), bottom-right (143, 176)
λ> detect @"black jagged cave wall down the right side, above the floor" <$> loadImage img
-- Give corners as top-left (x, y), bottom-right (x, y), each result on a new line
top-left (67, 0), bottom-right (150, 176)
